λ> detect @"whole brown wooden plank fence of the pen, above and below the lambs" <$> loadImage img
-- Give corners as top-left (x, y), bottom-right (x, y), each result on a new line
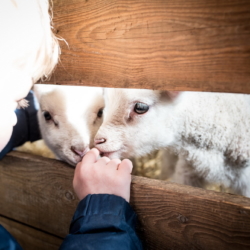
top-left (0, 0), bottom-right (250, 250)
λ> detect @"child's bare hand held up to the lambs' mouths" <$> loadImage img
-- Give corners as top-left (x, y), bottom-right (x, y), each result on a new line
top-left (73, 148), bottom-right (133, 202)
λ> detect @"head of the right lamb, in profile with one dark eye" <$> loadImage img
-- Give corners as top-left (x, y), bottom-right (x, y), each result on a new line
top-left (95, 89), bottom-right (179, 158)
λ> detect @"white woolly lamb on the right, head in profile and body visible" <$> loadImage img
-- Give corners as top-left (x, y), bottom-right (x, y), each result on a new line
top-left (95, 89), bottom-right (250, 197)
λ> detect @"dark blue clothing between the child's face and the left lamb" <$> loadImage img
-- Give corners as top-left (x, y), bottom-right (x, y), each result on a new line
top-left (0, 91), bottom-right (41, 160)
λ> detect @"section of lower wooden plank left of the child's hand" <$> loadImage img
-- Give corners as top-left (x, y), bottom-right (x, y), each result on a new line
top-left (0, 152), bottom-right (78, 237)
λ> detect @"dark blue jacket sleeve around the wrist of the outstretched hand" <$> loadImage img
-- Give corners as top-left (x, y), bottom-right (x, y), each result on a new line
top-left (60, 194), bottom-right (142, 250)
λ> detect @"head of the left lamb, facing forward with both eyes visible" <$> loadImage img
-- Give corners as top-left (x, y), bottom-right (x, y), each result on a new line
top-left (35, 85), bottom-right (104, 165)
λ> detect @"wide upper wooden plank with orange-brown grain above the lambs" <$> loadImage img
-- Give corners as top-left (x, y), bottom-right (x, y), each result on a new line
top-left (45, 0), bottom-right (250, 93)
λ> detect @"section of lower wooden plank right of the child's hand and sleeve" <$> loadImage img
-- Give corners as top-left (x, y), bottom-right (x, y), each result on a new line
top-left (131, 177), bottom-right (250, 250)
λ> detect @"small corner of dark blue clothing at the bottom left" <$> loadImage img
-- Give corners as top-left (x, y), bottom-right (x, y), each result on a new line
top-left (0, 225), bottom-right (22, 250)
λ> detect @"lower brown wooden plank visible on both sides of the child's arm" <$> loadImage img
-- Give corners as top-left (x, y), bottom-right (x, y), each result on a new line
top-left (0, 152), bottom-right (250, 250)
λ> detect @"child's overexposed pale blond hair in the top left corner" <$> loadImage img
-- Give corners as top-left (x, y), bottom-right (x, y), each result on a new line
top-left (0, 0), bottom-right (59, 85)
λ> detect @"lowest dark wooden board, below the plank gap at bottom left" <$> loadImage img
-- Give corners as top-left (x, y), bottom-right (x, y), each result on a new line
top-left (0, 216), bottom-right (63, 250)
